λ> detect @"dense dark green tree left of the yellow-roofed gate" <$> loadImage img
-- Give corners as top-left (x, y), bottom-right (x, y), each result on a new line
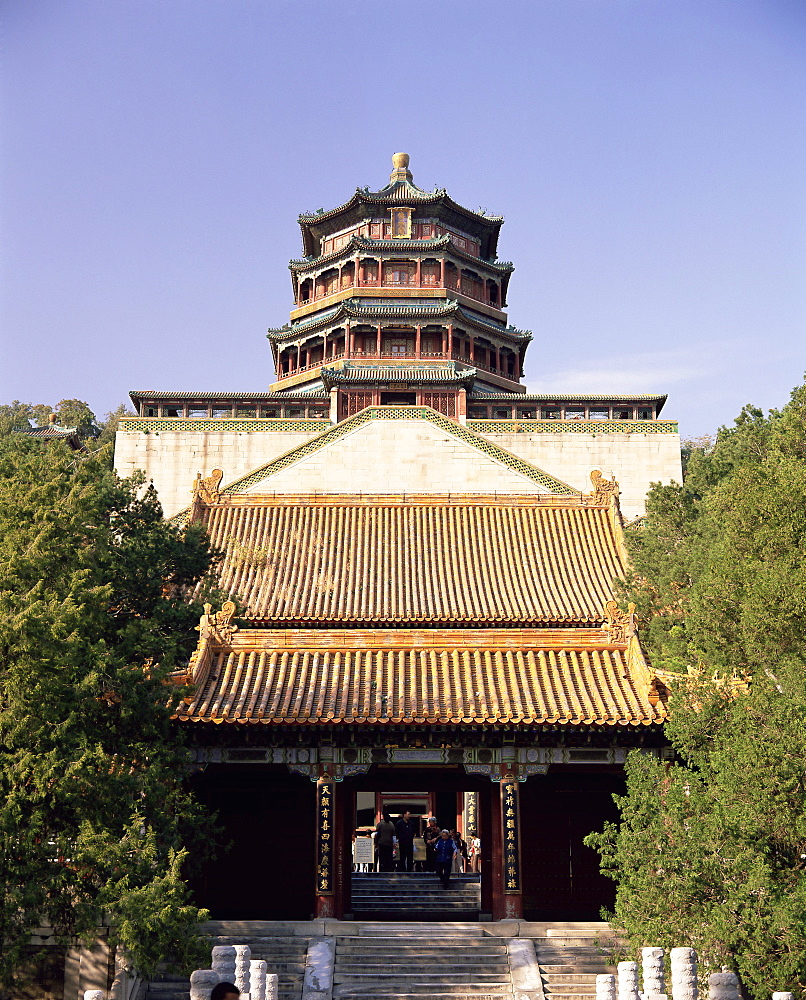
top-left (0, 433), bottom-right (219, 995)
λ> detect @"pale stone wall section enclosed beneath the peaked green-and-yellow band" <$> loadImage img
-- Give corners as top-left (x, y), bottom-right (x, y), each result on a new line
top-left (240, 420), bottom-right (549, 493)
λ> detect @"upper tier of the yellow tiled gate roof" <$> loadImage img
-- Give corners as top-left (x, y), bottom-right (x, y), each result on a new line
top-left (199, 494), bottom-right (625, 625)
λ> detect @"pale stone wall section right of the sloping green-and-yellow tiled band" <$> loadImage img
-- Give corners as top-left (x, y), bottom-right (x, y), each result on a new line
top-left (484, 433), bottom-right (682, 521)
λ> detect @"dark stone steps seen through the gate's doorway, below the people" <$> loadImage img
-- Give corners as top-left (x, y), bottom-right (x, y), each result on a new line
top-left (351, 872), bottom-right (481, 920)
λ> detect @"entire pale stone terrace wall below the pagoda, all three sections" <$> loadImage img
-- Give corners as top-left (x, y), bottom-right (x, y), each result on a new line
top-left (115, 420), bottom-right (681, 520)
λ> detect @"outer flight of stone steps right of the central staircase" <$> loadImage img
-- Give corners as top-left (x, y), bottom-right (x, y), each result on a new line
top-left (535, 921), bottom-right (617, 1000)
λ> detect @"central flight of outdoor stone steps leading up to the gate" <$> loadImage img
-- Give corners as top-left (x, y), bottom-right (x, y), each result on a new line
top-left (333, 923), bottom-right (513, 1000)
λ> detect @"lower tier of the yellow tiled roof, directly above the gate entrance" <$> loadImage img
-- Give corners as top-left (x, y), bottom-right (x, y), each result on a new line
top-left (177, 629), bottom-right (666, 726)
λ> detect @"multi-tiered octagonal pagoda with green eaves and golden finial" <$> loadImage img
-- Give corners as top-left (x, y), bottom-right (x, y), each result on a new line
top-left (268, 153), bottom-right (532, 420)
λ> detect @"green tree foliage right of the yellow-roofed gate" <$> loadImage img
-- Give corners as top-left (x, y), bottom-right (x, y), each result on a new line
top-left (588, 378), bottom-right (806, 998)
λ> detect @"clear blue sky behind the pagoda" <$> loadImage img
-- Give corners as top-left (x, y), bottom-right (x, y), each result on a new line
top-left (0, 0), bottom-right (806, 435)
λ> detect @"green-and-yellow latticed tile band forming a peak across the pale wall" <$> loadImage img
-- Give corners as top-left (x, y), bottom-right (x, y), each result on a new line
top-left (171, 406), bottom-right (580, 523)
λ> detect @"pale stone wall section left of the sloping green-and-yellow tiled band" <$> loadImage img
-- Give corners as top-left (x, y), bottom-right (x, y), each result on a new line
top-left (115, 431), bottom-right (328, 517)
